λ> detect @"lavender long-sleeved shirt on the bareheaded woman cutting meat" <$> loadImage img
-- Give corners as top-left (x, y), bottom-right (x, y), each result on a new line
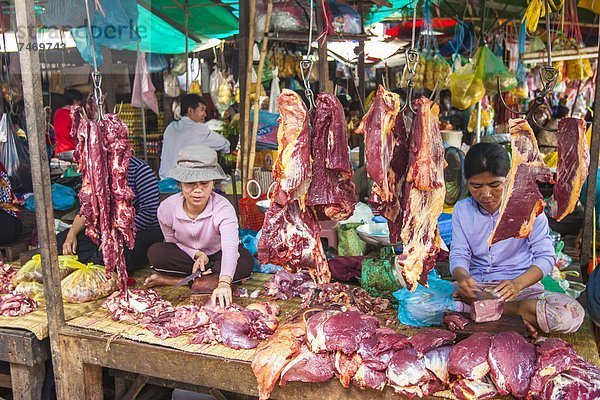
top-left (450, 197), bottom-right (555, 282)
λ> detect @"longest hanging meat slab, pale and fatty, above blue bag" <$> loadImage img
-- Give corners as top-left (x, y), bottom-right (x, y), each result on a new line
top-left (395, 97), bottom-right (446, 291)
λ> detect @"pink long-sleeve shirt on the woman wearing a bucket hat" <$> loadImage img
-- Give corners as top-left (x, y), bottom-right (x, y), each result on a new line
top-left (158, 192), bottom-right (239, 277)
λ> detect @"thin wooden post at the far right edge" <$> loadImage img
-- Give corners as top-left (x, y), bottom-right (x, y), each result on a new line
top-left (579, 62), bottom-right (600, 283)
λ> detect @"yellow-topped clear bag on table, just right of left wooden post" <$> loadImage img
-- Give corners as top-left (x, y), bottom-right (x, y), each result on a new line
top-left (60, 258), bottom-right (118, 303)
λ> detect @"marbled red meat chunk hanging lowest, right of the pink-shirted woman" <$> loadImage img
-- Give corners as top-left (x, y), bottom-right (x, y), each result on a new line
top-left (258, 200), bottom-right (331, 284)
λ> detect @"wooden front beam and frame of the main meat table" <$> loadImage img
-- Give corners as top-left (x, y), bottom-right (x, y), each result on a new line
top-left (57, 327), bottom-right (446, 400)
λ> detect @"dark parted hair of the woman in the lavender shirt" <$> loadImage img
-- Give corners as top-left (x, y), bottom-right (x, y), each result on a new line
top-left (465, 143), bottom-right (510, 179)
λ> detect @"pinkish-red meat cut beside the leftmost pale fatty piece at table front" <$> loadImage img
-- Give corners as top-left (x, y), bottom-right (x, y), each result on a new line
top-left (280, 345), bottom-right (335, 386)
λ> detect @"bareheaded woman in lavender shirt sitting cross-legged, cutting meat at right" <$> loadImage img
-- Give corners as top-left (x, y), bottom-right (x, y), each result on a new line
top-left (450, 143), bottom-right (585, 335)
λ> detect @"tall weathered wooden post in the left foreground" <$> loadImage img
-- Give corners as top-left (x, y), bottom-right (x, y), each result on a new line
top-left (15, 0), bottom-right (65, 399)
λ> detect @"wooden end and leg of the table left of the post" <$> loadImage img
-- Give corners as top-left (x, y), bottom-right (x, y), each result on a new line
top-left (0, 328), bottom-right (49, 400)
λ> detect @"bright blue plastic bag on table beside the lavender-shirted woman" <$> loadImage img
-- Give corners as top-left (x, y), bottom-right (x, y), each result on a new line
top-left (394, 270), bottom-right (456, 327)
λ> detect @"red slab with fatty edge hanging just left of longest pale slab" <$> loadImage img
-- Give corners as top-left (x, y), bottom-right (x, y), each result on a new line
top-left (356, 85), bottom-right (400, 203)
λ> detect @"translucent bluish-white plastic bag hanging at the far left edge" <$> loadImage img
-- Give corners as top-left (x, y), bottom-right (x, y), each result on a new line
top-left (0, 113), bottom-right (33, 193)
